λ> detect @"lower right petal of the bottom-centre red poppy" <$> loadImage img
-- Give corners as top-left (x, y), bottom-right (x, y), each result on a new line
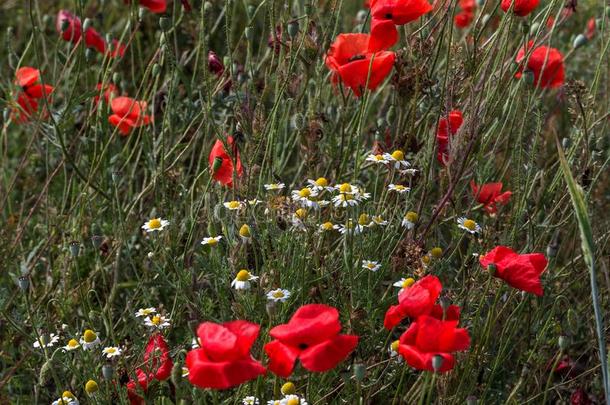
top-left (299, 335), bottom-right (358, 372)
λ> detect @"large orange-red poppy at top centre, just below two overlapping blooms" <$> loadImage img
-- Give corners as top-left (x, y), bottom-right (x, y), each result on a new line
top-left (326, 34), bottom-right (396, 97)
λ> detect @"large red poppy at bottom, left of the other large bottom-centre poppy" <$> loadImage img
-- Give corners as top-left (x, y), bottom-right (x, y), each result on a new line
top-left (186, 321), bottom-right (265, 389)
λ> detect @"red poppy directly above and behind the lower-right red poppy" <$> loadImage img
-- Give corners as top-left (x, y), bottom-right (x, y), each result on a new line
top-left (383, 275), bottom-right (443, 330)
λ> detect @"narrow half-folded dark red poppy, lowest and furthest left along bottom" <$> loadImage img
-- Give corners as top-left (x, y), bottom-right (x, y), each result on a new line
top-left (127, 333), bottom-right (174, 405)
